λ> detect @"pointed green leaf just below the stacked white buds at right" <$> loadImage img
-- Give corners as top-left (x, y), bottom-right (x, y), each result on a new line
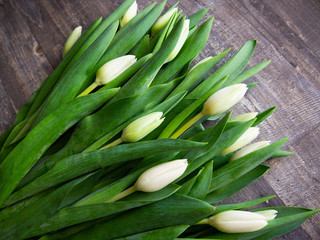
top-left (210, 138), bottom-right (287, 192)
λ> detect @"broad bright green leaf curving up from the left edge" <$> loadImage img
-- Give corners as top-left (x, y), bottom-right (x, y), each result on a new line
top-left (0, 89), bottom-right (118, 205)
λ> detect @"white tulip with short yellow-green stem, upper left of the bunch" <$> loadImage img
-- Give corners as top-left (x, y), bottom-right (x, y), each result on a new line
top-left (78, 55), bottom-right (137, 97)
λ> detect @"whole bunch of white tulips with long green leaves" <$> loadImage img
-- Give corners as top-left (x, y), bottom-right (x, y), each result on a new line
top-left (0, 0), bottom-right (317, 240)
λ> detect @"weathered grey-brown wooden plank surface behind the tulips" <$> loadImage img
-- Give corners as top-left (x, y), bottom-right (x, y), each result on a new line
top-left (0, 0), bottom-right (320, 240)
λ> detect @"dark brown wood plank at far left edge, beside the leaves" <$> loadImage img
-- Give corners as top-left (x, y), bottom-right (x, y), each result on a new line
top-left (0, 2), bottom-right (52, 133)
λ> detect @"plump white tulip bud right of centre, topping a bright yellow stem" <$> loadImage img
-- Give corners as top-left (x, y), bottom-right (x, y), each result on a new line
top-left (202, 83), bottom-right (248, 116)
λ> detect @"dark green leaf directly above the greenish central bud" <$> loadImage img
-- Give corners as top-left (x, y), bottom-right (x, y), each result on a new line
top-left (23, 80), bottom-right (182, 185)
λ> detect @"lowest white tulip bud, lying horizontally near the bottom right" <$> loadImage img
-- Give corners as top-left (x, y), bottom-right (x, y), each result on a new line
top-left (209, 211), bottom-right (268, 233)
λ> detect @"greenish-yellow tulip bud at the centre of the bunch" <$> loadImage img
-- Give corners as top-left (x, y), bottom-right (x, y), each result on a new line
top-left (121, 112), bottom-right (164, 142)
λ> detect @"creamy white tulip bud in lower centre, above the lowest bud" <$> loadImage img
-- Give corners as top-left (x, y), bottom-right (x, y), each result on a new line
top-left (135, 159), bottom-right (188, 192)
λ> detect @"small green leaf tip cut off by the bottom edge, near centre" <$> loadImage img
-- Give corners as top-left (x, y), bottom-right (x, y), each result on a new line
top-left (116, 225), bottom-right (188, 240)
